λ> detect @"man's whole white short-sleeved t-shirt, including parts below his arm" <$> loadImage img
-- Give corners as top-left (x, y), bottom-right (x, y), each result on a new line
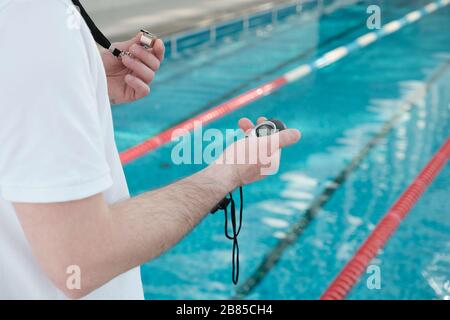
top-left (0, 0), bottom-right (143, 299)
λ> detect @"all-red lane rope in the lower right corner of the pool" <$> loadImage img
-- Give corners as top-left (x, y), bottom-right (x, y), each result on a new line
top-left (320, 136), bottom-right (450, 300)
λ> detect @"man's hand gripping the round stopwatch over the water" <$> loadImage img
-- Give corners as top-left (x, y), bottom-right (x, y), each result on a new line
top-left (215, 117), bottom-right (301, 186)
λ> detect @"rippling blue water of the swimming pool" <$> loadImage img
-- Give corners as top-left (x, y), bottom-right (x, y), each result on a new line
top-left (113, 0), bottom-right (450, 299)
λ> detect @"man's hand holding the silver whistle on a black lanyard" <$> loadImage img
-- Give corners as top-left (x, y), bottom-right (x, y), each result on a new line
top-left (101, 32), bottom-right (165, 104)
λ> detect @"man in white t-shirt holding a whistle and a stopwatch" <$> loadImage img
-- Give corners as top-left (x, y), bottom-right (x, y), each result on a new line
top-left (0, 0), bottom-right (300, 299)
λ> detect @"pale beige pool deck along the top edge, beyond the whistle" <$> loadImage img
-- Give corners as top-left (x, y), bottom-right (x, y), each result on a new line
top-left (85, 0), bottom-right (295, 41)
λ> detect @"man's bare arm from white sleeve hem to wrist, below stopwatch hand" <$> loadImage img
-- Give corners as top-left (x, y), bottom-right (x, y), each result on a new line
top-left (15, 165), bottom-right (239, 298)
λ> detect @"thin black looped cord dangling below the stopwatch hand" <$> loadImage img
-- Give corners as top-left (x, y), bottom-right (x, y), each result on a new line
top-left (221, 187), bottom-right (244, 285)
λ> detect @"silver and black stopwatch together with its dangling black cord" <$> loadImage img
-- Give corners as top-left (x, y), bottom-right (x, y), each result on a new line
top-left (211, 119), bottom-right (287, 285)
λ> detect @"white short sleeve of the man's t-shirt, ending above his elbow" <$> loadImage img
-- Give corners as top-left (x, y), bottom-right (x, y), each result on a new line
top-left (0, 0), bottom-right (112, 203)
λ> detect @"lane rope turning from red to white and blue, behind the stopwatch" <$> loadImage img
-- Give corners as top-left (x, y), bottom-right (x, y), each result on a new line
top-left (120, 0), bottom-right (450, 165)
